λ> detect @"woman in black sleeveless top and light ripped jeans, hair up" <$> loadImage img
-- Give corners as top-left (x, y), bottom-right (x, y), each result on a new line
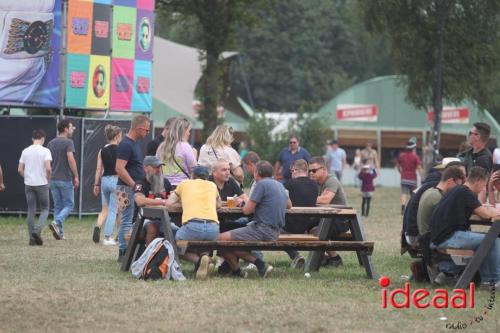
top-left (92, 124), bottom-right (122, 245)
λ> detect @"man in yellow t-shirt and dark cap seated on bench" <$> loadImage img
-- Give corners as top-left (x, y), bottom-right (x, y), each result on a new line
top-left (167, 166), bottom-right (222, 280)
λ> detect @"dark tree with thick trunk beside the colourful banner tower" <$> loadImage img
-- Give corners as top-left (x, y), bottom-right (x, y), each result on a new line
top-left (156, 0), bottom-right (263, 138)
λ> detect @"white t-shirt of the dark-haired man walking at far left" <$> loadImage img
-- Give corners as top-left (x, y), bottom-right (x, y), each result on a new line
top-left (19, 145), bottom-right (52, 186)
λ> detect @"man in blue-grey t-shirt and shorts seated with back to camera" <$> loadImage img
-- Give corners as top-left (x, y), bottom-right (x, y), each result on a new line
top-left (219, 161), bottom-right (292, 278)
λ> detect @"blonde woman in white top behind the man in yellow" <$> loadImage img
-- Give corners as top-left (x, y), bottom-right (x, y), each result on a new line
top-left (198, 125), bottom-right (243, 184)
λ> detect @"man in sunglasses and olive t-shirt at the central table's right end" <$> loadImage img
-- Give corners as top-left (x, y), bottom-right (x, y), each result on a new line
top-left (309, 156), bottom-right (349, 267)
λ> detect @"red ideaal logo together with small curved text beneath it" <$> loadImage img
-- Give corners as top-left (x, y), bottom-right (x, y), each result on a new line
top-left (379, 276), bottom-right (495, 330)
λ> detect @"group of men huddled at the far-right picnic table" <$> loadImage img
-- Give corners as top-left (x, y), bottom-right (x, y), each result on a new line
top-left (402, 122), bottom-right (500, 287)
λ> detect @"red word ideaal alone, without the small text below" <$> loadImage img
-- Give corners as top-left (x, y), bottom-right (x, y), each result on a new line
top-left (379, 276), bottom-right (474, 309)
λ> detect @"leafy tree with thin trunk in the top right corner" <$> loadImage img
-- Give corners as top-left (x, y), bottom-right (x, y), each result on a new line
top-left (358, 0), bottom-right (500, 158)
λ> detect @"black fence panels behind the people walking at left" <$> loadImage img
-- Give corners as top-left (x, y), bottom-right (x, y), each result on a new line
top-left (0, 116), bottom-right (153, 215)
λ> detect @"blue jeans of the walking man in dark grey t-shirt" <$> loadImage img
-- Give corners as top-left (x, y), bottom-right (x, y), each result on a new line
top-left (50, 180), bottom-right (75, 235)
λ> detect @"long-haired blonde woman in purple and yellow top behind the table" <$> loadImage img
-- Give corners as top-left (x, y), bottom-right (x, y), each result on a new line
top-left (156, 118), bottom-right (196, 187)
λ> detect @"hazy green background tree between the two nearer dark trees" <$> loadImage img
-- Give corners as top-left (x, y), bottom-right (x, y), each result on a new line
top-left (231, 0), bottom-right (392, 112)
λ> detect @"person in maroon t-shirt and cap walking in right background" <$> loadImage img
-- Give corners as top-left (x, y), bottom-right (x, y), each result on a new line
top-left (398, 138), bottom-right (422, 215)
